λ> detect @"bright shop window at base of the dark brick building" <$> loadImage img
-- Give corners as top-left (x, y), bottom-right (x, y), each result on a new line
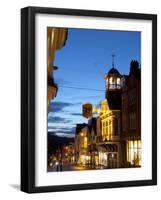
top-left (126, 140), bottom-right (141, 166)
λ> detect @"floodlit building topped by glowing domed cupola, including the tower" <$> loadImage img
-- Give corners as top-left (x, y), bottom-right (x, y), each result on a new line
top-left (97, 65), bottom-right (125, 168)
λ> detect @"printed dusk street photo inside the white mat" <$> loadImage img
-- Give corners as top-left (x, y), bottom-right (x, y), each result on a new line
top-left (47, 27), bottom-right (142, 172)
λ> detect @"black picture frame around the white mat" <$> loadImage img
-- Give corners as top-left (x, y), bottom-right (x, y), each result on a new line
top-left (21, 7), bottom-right (157, 193)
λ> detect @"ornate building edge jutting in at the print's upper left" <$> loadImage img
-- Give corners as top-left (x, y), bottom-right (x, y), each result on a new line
top-left (47, 27), bottom-right (67, 107)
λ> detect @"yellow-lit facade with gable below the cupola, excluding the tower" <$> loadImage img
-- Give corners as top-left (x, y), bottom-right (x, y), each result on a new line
top-left (97, 100), bottom-right (123, 168)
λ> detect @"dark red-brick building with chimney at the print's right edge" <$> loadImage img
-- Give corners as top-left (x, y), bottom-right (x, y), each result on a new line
top-left (122, 61), bottom-right (141, 166)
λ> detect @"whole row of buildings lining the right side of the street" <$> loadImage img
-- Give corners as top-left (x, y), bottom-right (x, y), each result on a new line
top-left (75, 61), bottom-right (141, 168)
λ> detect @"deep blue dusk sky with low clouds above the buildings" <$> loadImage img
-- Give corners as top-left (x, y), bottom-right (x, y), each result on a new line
top-left (48, 28), bottom-right (141, 137)
